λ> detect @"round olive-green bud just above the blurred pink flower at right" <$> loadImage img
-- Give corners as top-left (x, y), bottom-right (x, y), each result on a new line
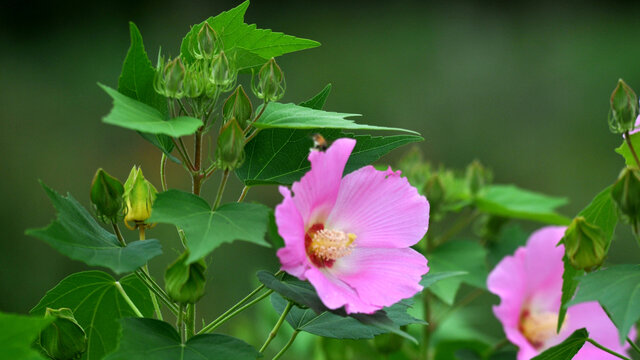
top-left (561, 216), bottom-right (610, 271)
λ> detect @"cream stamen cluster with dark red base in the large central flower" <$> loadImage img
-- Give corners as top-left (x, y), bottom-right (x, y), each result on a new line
top-left (305, 224), bottom-right (356, 267)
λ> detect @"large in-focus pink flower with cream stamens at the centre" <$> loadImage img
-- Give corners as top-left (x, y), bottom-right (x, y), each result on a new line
top-left (275, 139), bottom-right (429, 313)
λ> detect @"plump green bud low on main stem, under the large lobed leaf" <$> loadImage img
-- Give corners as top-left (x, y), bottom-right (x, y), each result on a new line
top-left (164, 251), bottom-right (207, 304)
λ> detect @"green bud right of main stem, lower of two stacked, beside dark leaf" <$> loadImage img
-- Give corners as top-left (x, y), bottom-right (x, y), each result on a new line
top-left (216, 118), bottom-right (244, 170)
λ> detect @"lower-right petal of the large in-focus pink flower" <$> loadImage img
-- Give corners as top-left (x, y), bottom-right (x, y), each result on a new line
top-left (327, 247), bottom-right (429, 312)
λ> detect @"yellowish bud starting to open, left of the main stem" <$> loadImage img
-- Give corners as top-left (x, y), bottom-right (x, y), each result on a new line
top-left (124, 166), bottom-right (158, 230)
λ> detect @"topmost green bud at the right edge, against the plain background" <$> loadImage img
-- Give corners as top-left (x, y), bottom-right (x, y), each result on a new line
top-left (609, 79), bottom-right (638, 134)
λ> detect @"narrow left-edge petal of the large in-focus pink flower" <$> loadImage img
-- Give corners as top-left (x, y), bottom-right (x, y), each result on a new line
top-left (275, 186), bottom-right (309, 280)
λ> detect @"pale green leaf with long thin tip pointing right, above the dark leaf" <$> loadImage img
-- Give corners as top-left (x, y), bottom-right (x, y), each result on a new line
top-left (253, 102), bottom-right (419, 135)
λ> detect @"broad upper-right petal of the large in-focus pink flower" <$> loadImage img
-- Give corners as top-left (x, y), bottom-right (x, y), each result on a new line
top-left (325, 166), bottom-right (429, 248)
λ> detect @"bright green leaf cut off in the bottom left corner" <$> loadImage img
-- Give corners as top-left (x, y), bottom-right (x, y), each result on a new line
top-left (0, 313), bottom-right (53, 360)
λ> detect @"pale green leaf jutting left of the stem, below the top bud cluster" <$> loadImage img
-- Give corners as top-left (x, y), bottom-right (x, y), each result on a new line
top-left (98, 84), bottom-right (202, 138)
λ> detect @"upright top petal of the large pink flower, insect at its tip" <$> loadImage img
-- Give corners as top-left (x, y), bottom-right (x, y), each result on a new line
top-left (291, 138), bottom-right (356, 227)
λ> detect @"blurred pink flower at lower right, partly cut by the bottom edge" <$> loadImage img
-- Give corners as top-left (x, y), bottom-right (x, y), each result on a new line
top-left (487, 226), bottom-right (635, 360)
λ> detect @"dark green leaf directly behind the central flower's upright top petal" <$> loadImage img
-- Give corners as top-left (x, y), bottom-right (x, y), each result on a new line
top-left (236, 129), bottom-right (423, 186)
